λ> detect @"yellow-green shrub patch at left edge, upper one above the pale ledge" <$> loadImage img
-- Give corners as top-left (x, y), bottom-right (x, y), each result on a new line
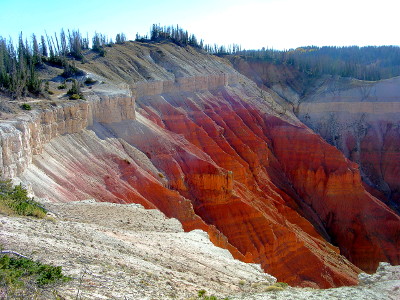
top-left (0, 180), bottom-right (47, 218)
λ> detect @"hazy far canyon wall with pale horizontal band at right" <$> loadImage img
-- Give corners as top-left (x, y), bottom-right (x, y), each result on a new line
top-left (230, 56), bottom-right (400, 213)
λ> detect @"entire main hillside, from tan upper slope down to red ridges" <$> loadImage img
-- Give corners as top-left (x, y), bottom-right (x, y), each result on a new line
top-left (2, 44), bottom-right (400, 288)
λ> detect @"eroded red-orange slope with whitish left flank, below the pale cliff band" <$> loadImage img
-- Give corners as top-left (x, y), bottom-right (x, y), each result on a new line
top-left (25, 81), bottom-right (400, 287)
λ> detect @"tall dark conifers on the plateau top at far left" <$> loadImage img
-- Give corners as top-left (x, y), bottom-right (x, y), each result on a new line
top-left (0, 29), bottom-right (126, 98)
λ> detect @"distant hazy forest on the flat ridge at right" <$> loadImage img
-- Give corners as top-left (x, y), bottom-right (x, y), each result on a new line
top-left (236, 46), bottom-right (400, 81)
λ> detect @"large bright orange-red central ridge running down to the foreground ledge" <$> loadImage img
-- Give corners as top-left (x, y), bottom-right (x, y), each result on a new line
top-left (134, 86), bottom-right (366, 287)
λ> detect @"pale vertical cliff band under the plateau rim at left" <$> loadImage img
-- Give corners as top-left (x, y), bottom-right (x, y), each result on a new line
top-left (0, 90), bottom-right (135, 178)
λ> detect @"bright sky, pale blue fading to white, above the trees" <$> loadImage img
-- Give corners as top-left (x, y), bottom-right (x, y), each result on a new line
top-left (0, 0), bottom-right (400, 49)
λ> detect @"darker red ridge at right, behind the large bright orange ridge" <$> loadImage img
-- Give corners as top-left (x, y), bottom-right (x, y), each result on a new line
top-left (268, 118), bottom-right (400, 272)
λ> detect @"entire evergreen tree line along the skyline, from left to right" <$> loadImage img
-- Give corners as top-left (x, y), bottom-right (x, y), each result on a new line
top-left (0, 24), bottom-right (400, 98)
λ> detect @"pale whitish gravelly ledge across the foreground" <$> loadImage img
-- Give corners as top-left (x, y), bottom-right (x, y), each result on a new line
top-left (0, 200), bottom-right (400, 300)
